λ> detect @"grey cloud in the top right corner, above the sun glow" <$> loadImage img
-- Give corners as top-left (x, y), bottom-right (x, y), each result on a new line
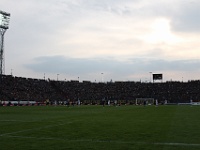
top-left (144, 0), bottom-right (200, 33)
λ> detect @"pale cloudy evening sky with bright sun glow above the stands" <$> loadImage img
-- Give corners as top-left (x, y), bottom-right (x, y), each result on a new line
top-left (0, 0), bottom-right (200, 82)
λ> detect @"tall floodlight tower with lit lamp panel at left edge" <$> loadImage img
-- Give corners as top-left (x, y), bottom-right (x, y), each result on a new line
top-left (0, 10), bottom-right (10, 75)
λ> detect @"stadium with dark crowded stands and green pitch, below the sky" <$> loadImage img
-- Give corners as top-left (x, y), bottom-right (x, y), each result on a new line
top-left (0, 75), bottom-right (200, 150)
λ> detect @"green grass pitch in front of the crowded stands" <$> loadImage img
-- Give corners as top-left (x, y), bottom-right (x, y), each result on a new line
top-left (0, 106), bottom-right (200, 150)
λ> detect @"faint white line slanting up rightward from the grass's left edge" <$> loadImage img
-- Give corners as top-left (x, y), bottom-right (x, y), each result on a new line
top-left (0, 122), bottom-right (72, 137)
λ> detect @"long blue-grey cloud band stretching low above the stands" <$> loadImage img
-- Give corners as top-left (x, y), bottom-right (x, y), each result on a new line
top-left (25, 56), bottom-right (200, 75)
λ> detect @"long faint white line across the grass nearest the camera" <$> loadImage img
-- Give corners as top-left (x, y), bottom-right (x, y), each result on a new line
top-left (0, 135), bottom-right (200, 147)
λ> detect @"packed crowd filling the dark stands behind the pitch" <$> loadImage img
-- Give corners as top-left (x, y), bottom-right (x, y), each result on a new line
top-left (0, 75), bottom-right (200, 103)
